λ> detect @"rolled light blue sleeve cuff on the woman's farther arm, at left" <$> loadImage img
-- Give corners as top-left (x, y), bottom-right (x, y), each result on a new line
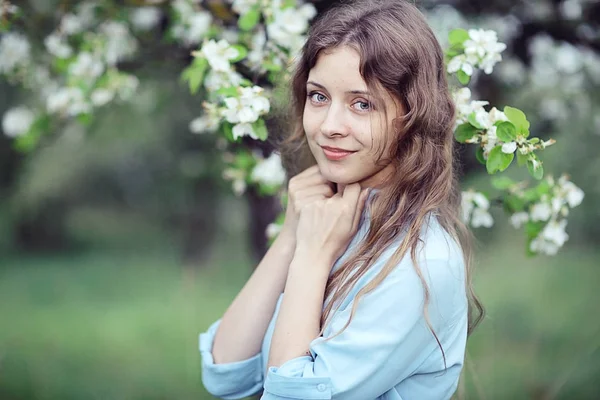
top-left (199, 319), bottom-right (264, 399)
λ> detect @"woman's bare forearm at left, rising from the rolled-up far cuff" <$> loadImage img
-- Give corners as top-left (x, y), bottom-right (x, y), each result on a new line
top-left (212, 231), bottom-right (295, 364)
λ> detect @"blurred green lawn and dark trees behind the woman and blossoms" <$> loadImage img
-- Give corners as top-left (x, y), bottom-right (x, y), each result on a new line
top-left (0, 0), bottom-right (600, 400)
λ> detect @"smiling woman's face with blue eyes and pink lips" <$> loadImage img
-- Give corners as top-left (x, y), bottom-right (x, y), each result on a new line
top-left (303, 46), bottom-right (401, 187)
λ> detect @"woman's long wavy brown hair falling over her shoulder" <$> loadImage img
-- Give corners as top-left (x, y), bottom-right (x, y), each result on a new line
top-left (280, 0), bottom-right (484, 359)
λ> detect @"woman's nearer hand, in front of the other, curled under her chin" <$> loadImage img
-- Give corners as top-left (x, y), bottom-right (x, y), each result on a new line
top-left (296, 183), bottom-right (368, 272)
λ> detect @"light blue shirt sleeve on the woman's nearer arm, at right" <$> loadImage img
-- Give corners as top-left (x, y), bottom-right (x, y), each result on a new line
top-left (261, 260), bottom-right (466, 400)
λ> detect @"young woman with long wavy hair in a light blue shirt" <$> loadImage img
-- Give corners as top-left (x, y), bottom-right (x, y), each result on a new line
top-left (200, 0), bottom-right (482, 400)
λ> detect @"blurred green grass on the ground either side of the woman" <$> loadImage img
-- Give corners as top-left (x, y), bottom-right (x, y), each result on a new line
top-left (0, 230), bottom-right (600, 400)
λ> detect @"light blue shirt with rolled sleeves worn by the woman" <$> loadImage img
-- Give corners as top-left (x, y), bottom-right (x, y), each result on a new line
top-left (200, 205), bottom-right (467, 400)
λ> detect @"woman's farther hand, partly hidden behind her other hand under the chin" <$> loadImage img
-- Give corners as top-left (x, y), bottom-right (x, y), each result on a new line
top-left (281, 165), bottom-right (333, 242)
